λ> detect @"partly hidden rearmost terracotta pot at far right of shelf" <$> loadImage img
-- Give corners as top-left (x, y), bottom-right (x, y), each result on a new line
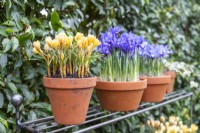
top-left (164, 71), bottom-right (176, 93)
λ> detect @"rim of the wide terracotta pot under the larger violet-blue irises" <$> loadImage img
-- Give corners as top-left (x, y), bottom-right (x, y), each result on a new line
top-left (95, 78), bottom-right (147, 91)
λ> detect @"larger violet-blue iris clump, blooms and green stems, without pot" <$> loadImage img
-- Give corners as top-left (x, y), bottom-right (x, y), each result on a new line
top-left (98, 27), bottom-right (145, 81)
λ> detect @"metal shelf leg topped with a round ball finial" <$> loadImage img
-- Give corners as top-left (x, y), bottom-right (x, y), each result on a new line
top-left (11, 94), bottom-right (23, 133)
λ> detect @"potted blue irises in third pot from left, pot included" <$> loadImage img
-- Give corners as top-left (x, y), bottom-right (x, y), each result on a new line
top-left (139, 43), bottom-right (172, 102)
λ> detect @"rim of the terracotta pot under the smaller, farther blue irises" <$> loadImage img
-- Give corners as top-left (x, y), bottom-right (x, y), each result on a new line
top-left (146, 75), bottom-right (171, 85)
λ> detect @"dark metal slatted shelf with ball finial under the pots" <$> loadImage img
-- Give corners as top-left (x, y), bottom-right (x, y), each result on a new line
top-left (11, 91), bottom-right (193, 133)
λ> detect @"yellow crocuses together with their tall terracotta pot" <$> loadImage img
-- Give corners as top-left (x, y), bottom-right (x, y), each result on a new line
top-left (33, 32), bottom-right (100, 125)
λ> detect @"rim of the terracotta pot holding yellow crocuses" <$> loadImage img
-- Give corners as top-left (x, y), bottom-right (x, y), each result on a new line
top-left (43, 77), bottom-right (97, 89)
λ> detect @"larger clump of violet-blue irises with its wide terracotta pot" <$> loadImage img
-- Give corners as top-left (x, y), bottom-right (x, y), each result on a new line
top-left (95, 27), bottom-right (147, 111)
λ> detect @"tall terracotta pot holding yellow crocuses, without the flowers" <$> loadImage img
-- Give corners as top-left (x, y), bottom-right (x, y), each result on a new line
top-left (43, 77), bottom-right (96, 125)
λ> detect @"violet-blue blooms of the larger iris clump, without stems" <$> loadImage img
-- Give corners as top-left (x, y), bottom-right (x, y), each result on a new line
top-left (98, 27), bottom-right (145, 55)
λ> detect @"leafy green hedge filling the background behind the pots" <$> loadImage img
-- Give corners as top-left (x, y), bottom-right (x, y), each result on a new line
top-left (0, 0), bottom-right (200, 133)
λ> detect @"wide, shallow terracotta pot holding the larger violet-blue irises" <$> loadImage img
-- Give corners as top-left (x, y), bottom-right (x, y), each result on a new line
top-left (95, 79), bottom-right (147, 111)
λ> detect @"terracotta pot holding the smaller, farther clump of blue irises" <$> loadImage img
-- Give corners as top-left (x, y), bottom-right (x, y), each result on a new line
top-left (142, 75), bottom-right (171, 102)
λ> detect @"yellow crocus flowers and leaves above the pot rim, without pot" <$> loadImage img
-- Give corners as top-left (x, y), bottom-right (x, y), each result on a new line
top-left (33, 32), bottom-right (100, 78)
